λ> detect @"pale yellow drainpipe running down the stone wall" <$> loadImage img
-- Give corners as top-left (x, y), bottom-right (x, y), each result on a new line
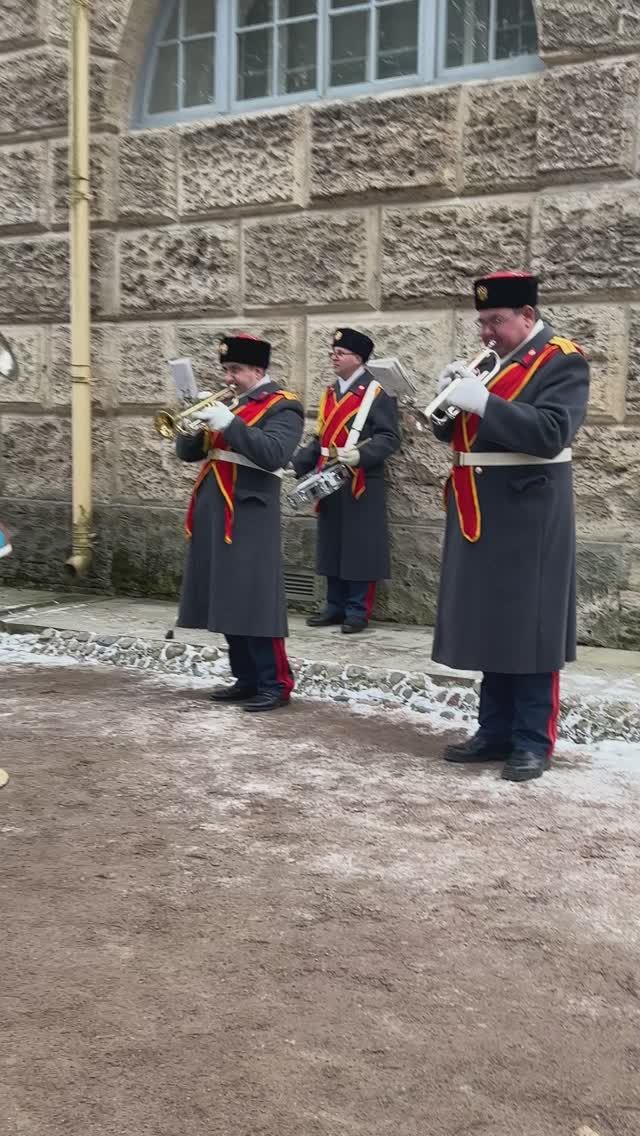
top-left (65, 0), bottom-right (92, 577)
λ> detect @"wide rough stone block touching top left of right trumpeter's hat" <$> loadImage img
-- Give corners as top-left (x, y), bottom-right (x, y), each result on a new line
top-left (382, 201), bottom-right (529, 306)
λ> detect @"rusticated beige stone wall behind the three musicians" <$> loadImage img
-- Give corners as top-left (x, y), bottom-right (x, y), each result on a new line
top-left (0, 0), bottom-right (640, 646)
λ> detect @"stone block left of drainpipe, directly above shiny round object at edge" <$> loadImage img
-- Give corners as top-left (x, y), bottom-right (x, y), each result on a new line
top-left (0, 236), bottom-right (69, 320)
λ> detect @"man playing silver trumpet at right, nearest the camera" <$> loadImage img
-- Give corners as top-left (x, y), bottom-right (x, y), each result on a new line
top-left (433, 273), bottom-right (589, 782)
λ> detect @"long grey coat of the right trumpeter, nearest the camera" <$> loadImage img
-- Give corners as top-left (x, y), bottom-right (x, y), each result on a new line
top-left (433, 326), bottom-right (589, 675)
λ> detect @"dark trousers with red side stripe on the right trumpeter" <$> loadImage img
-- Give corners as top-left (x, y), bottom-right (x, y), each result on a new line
top-left (479, 670), bottom-right (560, 757)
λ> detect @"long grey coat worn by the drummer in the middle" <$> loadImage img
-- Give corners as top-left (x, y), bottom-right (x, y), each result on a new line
top-left (293, 371), bottom-right (400, 580)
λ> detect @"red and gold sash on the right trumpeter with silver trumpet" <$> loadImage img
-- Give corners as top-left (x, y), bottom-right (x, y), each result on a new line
top-left (446, 340), bottom-right (563, 544)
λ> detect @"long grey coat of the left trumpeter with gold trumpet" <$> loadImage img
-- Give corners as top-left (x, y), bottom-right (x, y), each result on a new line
top-left (176, 383), bottom-right (304, 638)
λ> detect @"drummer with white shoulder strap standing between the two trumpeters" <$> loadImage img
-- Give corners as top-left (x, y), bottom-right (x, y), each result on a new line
top-left (293, 327), bottom-right (400, 635)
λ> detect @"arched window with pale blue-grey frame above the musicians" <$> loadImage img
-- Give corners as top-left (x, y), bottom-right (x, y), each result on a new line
top-left (138, 0), bottom-right (539, 125)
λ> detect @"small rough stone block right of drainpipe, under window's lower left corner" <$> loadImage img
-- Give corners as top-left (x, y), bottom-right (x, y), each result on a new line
top-left (118, 131), bottom-right (177, 223)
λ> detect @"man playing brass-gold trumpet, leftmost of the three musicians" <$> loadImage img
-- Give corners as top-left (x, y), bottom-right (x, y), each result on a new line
top-left (176, 334), bottom-right (304, 711)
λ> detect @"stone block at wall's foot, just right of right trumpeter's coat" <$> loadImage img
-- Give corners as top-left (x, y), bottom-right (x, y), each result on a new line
top-left (576, 541), bottom-right (622, 646)
